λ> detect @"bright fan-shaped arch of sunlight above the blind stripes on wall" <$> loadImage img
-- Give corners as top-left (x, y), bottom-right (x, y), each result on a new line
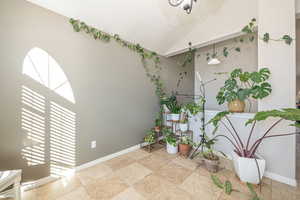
top-left (23, 48), bottom-right (75, 103)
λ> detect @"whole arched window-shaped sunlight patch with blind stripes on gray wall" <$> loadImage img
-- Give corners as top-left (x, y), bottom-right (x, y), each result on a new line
top-left (21, 48), bottom-right (76, 176)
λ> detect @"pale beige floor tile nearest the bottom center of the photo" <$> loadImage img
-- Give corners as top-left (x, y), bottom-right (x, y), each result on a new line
top-left (134, 174), bottom-right (175, 199)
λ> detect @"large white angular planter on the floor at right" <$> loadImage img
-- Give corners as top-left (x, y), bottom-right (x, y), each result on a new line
top-left (232, 152), bottom-right (266, 184)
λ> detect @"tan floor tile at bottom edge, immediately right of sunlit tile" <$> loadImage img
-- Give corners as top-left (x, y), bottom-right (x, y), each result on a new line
top-left (84, 175), bottom-right (129, 200)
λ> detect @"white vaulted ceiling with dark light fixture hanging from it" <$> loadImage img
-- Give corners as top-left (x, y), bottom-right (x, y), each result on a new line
top-left (28, 0), bottom-right (257, 56)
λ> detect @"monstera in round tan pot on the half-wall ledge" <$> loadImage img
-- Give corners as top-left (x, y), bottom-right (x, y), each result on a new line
top-left (216, 68), bottom-right (272, 112)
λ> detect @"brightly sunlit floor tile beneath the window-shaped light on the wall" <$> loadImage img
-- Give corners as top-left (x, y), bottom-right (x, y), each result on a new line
top-left (36, 176), bottom-right (81, 200)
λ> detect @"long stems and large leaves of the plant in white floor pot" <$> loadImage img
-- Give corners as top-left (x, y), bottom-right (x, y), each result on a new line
top-left (208, 108), bottom-right (300, 158)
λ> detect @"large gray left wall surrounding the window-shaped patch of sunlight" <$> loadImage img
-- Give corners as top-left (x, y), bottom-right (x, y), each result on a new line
top-left (0, 0), bottom-right (194, 180)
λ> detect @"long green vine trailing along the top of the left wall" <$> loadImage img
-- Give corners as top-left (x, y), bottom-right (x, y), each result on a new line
top-left (69, 18), bottom-right (166, 98)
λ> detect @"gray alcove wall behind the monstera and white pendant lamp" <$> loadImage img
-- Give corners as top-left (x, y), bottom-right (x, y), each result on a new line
top-left (195, 36), bottom-right (257, 112)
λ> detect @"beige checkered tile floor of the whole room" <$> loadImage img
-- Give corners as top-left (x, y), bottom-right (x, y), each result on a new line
top-left (18, 149), bottom-right (300, 200)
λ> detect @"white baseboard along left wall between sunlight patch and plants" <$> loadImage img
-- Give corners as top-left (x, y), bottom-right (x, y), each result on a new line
top-left (75, 144), bottom-right (141, 171)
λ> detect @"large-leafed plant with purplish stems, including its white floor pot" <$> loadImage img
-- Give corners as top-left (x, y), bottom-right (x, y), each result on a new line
top-left (208, 108), bottom-right (300, 184)
